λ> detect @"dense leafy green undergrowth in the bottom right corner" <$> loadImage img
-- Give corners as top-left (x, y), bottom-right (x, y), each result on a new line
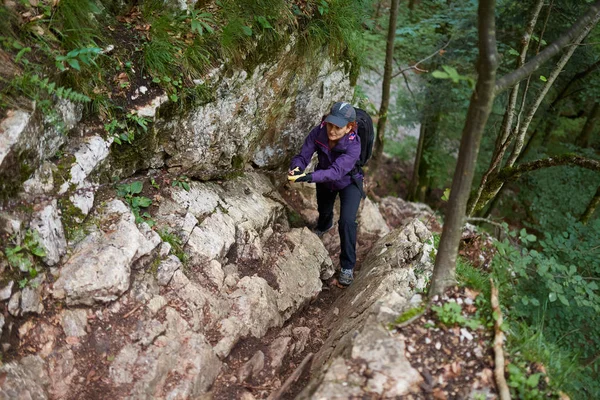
top-left (493, 220), bottom-right (600, 398)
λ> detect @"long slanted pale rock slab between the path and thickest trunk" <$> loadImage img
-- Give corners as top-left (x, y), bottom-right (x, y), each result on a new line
top-left (298, 219), bottom-right (433, 399)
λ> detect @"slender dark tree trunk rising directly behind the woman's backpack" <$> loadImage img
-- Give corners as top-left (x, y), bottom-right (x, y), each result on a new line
top-left (373, 0), bottom-right (400, 170)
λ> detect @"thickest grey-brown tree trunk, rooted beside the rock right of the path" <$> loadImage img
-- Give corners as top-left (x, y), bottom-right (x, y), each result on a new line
top-left (429, 0), bottom-right (498, 296)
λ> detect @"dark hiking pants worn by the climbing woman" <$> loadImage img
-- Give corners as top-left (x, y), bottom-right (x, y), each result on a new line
top-left (317, 180), bottom-right (362, 269)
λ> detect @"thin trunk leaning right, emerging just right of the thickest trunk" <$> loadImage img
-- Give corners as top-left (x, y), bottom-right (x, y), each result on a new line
top-left (467, 0), bottom-right (544, 216)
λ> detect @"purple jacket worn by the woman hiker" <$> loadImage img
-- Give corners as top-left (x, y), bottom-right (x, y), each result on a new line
top-left (290, 122), bottom-right (362, 190)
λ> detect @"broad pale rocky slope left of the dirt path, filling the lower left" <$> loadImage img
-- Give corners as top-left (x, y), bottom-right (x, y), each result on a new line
top-left (3, 173), bottom-right (333, 399)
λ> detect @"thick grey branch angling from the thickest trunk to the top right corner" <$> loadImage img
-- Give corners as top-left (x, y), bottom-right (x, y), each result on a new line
top-left (495, 0), bottom-right (600, 95)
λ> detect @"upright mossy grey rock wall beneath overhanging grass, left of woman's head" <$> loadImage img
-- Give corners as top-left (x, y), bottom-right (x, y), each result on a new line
top-left (159, 57), bottom-right (352, 176)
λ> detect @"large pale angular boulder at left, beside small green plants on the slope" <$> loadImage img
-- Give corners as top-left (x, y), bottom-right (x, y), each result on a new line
top-left (54, 200), bottom-right (160, 305)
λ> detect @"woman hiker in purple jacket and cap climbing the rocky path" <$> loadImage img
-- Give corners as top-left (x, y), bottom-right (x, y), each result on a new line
top-left (288, 102), bottom-right (363, 286)
